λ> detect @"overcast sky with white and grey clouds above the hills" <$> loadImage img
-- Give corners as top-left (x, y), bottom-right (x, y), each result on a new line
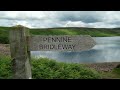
top-left (0, 11), bottom-right (120, 28)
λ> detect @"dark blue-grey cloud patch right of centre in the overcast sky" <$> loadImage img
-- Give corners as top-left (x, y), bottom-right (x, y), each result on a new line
top-left (56, 11), bottom-right (102, 23)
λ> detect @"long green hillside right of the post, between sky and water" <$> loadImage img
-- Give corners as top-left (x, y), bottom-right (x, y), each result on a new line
top-left (30, 27), bottom-right (120, 37)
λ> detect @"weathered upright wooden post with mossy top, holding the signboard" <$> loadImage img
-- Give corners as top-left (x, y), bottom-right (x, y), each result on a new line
top-left (9, 26), bottom-right (32, 79)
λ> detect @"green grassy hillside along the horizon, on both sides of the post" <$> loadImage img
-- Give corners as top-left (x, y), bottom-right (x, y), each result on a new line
top-left (0, 27), bottom-right (120, 44)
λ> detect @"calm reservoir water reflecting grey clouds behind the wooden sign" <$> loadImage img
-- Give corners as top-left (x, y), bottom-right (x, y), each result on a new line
top-left (31, 36), bottom-right (120, 63)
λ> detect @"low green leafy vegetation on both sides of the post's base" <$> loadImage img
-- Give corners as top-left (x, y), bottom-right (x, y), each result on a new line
top-left (0, 56), bottom-right (101, 79)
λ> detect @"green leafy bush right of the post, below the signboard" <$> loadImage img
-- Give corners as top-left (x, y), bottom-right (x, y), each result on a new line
top-left (32, 58), bottom-right (101, 79)
